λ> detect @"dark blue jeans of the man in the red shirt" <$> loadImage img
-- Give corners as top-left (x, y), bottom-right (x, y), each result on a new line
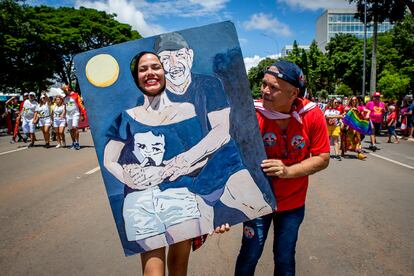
top-left (235, 206), bottom-right (305, 276)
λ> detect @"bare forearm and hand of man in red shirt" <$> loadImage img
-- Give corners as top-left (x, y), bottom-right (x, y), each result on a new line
top-left (261, 153), bottom-right (329, 178)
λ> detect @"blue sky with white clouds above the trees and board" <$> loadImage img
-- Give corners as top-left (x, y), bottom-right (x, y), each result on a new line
top-left (26, 0), bottom-right (350, 70)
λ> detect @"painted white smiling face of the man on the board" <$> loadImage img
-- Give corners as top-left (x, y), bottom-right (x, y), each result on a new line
top-left (159, 48), bottom-right (193, 86)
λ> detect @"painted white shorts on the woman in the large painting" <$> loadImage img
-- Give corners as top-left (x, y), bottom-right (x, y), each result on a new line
top-left (122, 186), bottom-right (200, 241)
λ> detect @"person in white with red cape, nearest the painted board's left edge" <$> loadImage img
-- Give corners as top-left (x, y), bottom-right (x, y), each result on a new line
top-left (62, 85), bottom-right (85, 150)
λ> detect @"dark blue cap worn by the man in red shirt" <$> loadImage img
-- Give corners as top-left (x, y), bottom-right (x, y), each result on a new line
top-left (264, 60), bottom-right (305, 90)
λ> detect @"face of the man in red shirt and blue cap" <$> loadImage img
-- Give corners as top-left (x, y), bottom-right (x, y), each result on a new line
top-left (260, 67), bottom-right (299, 112)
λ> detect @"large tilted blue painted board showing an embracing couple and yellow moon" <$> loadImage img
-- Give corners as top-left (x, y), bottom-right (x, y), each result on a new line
top-left (75, 22), bottom-right (276, 255)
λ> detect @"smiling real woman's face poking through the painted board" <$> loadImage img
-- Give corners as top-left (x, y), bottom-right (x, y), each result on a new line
top-left (137, 53), bottom-right (165, 96)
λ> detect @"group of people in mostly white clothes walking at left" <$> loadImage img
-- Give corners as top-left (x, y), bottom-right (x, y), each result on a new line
top-left (3, 85), bottom-right (86, 150)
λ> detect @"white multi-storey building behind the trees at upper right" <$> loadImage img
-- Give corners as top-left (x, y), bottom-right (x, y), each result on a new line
top-left (316, 8), bottom-right (393, 53)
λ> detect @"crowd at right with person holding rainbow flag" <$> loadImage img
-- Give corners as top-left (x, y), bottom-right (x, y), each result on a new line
top-left (318, 92), bottom-right (414, 161)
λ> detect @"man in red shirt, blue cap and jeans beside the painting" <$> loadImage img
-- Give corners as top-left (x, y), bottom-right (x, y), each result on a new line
top-left (235, 61), bottom-right (330, 275)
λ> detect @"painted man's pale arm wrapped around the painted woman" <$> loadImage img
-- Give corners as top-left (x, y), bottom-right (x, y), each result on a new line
top-left (162, 108), bottom-right (230, 181)
